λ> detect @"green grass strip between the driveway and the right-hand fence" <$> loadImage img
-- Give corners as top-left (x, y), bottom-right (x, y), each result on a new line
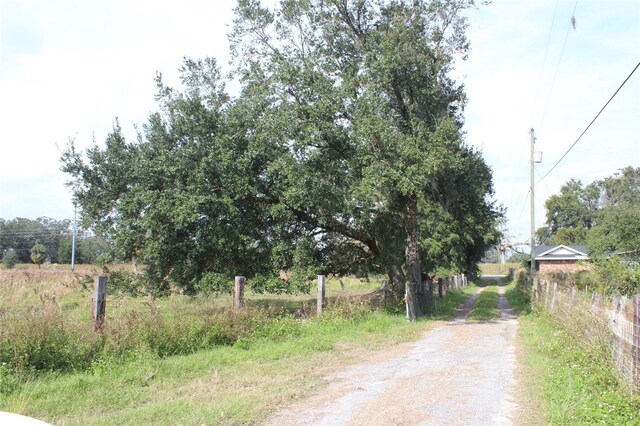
top-left (507, 284), bottom-right (640, 425)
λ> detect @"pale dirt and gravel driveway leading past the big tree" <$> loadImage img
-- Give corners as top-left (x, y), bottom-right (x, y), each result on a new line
top-left (266, 278), bottom-right (518, 426)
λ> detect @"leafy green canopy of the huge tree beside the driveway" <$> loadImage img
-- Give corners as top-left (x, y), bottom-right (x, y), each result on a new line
top-left (62, 0), bottom-right (501, 298)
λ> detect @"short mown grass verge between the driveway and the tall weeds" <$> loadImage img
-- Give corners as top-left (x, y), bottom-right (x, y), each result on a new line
top-left (0, 312), bottom-right (428, 425)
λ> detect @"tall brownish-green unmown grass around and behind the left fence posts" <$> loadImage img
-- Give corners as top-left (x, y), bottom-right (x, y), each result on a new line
top-left (0, 270), bottom-right (390, 374)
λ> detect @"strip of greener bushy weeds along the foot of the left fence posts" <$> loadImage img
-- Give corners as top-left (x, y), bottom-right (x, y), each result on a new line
top-left (0, 302), bottom-right (308, 372)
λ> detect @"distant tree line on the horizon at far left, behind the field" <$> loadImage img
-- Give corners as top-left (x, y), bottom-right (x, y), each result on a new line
top-left (0, 217), bottom-right (109, 264)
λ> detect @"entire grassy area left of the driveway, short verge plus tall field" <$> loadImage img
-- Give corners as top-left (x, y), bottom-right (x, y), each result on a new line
top-left (0, 268), bottom-right (466, 425)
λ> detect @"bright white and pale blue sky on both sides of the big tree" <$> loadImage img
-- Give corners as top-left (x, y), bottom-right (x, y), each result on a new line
top-left (0, 0), bottom-right (640, 248)
